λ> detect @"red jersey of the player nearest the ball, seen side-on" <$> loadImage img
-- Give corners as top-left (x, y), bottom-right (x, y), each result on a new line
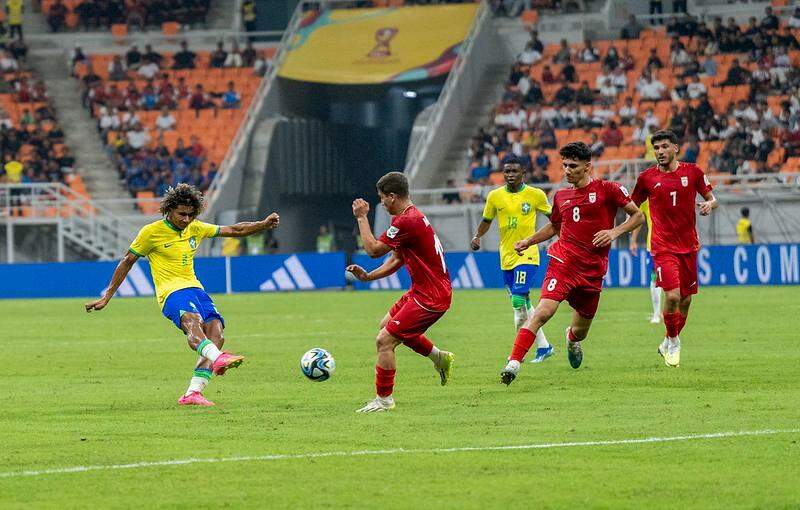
top-left (380, 205), bottom-right (453, 312)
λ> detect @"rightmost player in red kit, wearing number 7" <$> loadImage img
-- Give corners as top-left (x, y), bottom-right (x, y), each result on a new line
top-left (633, 130), bottom-right (717, 367)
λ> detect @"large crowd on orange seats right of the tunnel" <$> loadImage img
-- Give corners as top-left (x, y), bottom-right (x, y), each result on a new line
top-left (467, 7), bottom-right (800, 184)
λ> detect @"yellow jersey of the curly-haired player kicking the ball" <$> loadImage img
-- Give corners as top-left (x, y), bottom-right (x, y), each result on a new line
top-left (130, 218), bottom-right (220, 308)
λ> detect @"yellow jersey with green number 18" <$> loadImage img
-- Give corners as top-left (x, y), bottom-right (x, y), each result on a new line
top-left (483, 184), bottom-right (551, 270)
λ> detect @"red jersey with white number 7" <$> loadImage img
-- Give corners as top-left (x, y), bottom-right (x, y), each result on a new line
top-left (632, 163), bottom-right (712, 253)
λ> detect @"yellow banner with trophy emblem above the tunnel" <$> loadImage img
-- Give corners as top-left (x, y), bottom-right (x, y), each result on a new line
top-left (278, 4), bottom-right (478, 84)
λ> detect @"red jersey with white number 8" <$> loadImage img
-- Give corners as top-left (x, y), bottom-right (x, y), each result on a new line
top-left (547, 179), bottom-right (631, 278)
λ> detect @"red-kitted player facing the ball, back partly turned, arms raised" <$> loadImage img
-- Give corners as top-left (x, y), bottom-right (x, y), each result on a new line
top-left (347, 172), bottom-right (455, 413)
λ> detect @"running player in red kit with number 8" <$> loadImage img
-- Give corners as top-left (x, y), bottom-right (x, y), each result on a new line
top-left (500, 142), bottom-right (644, 384)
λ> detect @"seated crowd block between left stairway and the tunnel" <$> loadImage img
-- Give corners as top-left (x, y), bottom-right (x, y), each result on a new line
top-left (73, 38), bottom-right (265, 196)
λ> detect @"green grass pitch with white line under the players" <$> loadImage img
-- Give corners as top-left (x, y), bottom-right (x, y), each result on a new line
top-left (0, 287), bottom-right (800, 509)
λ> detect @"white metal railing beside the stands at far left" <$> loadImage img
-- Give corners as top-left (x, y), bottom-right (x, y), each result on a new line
top-left (0, 183), bottom-right (140, 262)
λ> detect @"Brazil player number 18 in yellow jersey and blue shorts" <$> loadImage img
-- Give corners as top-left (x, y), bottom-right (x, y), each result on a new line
top-left (470, 156), bottom-right (553, 363)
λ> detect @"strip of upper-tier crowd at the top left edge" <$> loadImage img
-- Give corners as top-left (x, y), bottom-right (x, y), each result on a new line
top-left (42, 0), bottom-right (210, 32)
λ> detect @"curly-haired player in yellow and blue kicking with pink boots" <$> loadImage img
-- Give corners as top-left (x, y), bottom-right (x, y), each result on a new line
top-left (85, 184), bottom-right (280, 406)
